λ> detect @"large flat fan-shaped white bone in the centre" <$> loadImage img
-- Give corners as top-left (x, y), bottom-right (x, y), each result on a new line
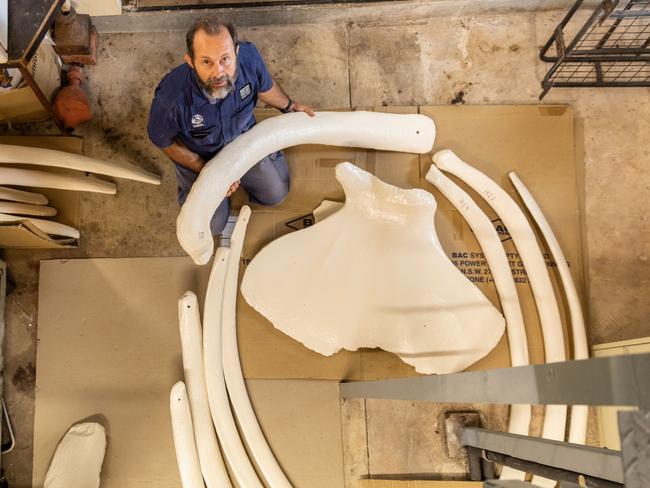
top-left (241, 163), bottom-right (504, 373)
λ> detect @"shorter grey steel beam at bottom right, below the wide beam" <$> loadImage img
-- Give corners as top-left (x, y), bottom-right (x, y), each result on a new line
top-left (462, 427), bottom-right (625, 486)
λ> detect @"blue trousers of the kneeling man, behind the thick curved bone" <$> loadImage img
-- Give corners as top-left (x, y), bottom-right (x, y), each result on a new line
top-left (176, 151), bottom-right (290, 235)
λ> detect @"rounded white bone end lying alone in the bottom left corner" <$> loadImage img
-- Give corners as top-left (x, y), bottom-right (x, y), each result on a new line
top-left (43, 422), bottom-right (106, 488)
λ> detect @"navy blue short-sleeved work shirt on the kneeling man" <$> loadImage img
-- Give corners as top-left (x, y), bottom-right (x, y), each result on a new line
top-left (147, 41), bottom-right (273, 175)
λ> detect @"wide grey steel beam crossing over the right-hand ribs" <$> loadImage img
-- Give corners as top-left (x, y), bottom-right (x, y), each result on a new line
top-left (341, 354), bottom-right (650, 409)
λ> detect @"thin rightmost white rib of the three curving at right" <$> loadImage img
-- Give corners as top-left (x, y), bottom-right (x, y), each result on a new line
top-left (508, 171), bottom-right (589, 444)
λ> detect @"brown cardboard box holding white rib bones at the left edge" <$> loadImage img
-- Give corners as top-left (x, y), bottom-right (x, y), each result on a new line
top-left (0, 136), bottom-right (83, 249)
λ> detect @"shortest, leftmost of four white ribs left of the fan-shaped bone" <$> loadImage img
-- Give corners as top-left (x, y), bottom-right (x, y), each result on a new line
top-left (169, 381), bottom-right (204, 488)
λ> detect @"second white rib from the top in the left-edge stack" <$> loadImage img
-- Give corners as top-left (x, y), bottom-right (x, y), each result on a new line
top-left (0, 167), bottom-right (117, 195)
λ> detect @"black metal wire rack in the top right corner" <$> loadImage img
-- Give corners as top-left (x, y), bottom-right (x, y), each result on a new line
top-left (539, 0), bottom-right (650, 100)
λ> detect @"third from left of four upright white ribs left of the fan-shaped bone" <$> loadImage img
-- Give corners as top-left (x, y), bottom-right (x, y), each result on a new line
top-left (203, 247), bottom-right (263, 488)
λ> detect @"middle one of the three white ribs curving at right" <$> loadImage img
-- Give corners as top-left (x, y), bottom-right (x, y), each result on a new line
top-left (434, 149), bottom-right (567, 487)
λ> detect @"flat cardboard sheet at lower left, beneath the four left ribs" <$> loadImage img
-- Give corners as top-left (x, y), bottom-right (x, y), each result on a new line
top-left (33, 258), bottom-right (343, 488)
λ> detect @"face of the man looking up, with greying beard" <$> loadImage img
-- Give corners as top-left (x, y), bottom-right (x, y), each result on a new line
top-left (185, 27), bottom-right (237, 99)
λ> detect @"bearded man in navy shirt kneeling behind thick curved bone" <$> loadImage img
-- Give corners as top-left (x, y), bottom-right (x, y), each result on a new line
top-left (148, 19), bottom-right (314, 235)
